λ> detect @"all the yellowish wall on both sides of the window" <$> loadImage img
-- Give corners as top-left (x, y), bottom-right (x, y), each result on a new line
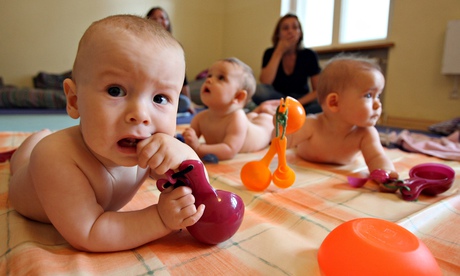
top-left (0, 0), bottom-right (460, 125)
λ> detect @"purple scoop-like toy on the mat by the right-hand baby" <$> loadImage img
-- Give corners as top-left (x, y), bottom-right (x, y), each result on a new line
top-left (348, 163), bottom-right (455, 201)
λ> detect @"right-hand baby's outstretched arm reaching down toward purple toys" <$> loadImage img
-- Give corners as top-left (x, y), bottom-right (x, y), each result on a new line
top-left (360, 127), bottom-right (399, 178)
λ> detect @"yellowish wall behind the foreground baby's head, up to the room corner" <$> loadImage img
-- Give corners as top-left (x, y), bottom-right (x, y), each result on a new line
top-left (0, 0), bottom-right (224, 87)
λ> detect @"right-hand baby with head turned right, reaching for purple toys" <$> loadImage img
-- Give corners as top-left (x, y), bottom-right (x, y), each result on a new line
top-left (287, 55), bottom-right (398, 178)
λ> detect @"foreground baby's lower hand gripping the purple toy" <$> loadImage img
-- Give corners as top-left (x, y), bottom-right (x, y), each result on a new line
top-left (158, 186), bottom-right (205, 230)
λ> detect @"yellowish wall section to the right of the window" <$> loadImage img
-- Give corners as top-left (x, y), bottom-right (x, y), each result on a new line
top-left (384, 0), bottom-right (460, 121)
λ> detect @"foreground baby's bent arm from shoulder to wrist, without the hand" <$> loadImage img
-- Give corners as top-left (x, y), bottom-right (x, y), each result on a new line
top-left (28, 135), bottom-right (182, 252)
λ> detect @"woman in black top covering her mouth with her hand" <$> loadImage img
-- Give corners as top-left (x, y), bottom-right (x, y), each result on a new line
top-left (252, 14), bottom-right (321, 113)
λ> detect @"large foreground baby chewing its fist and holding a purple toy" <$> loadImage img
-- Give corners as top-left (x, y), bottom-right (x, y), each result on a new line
top-left (9, 15), bottom-right (205, 252)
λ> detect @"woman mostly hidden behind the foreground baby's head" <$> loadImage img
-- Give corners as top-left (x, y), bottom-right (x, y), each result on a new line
top-left (146, 7), bottom-right (195, 114)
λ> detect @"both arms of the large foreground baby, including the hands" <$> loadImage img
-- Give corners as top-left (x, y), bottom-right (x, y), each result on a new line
top-left (29, 134), bottom-right (208, 252)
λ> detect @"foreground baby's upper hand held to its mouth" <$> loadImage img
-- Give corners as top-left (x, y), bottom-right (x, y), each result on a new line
top-left (137, 133), bottom-right (199, 175)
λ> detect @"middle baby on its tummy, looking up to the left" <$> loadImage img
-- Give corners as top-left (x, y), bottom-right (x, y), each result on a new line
top-left (182, 58), bottom-right (274, 160)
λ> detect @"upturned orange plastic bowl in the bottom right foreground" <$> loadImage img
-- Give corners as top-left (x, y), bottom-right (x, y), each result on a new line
top-left (318, 218), bottom-right (442, 276)
